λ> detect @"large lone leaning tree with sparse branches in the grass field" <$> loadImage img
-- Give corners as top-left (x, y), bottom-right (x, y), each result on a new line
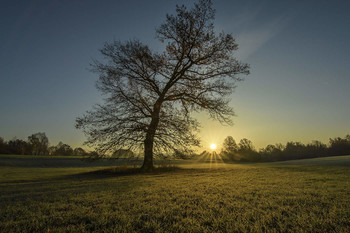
top-left (76, 0), bottom-right (249, 170)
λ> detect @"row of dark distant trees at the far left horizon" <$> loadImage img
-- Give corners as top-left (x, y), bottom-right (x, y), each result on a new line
top-left (0, 133), bottom-right (89, 156)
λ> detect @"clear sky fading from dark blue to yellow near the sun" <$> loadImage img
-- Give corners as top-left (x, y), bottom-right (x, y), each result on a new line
top-left (0, 0), bottom-right (350, 149)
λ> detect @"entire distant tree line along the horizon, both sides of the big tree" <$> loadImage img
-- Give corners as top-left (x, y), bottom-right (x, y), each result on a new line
top-left (0, 133), bottom-right (350, 162)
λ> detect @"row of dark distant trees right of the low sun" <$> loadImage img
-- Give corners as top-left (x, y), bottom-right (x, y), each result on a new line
top-left (221, 134), bottom-right (350, 162)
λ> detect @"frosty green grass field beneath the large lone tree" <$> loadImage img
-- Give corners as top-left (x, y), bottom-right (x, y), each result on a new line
top-left (0, 155), bottom-right (350, 232)
